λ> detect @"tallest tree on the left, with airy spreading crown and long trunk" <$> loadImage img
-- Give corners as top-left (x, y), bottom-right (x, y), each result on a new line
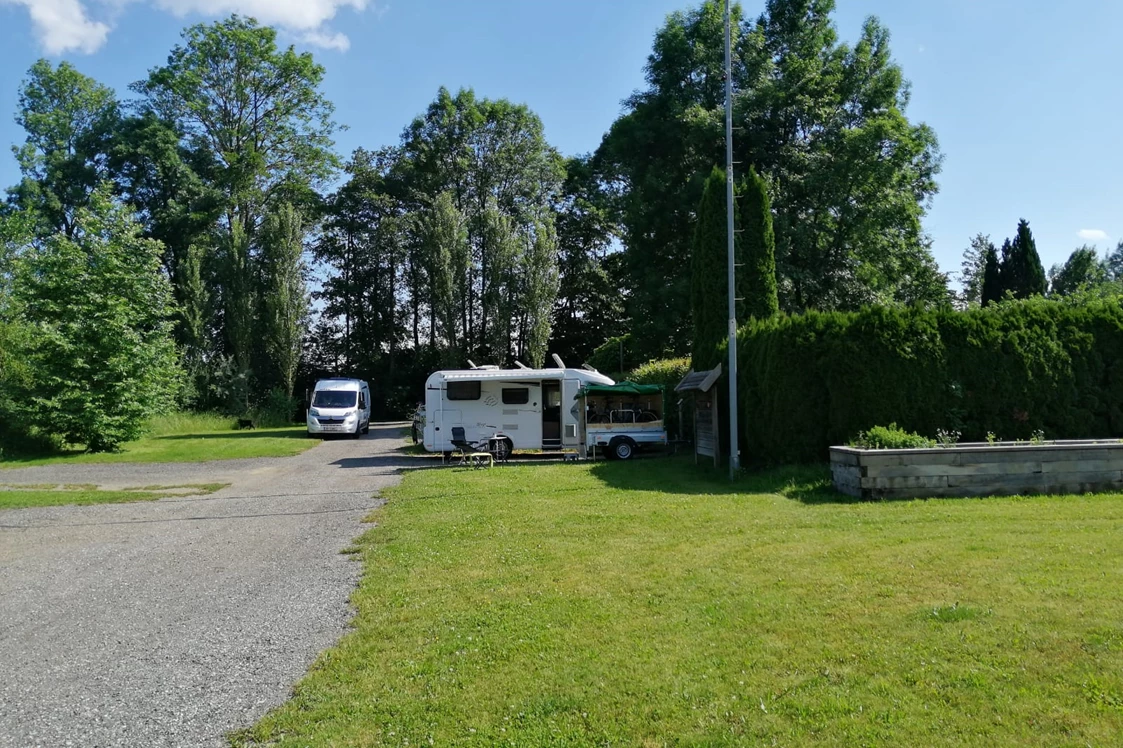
top-left (133, 16), bottom-right (338, 393)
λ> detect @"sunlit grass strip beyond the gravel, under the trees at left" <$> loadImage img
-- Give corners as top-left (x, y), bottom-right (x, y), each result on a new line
top-left (0, 413), bottom-right (319, 468)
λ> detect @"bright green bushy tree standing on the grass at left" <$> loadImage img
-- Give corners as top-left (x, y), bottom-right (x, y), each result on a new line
top-left (16, 188), bottom-right (177, 451)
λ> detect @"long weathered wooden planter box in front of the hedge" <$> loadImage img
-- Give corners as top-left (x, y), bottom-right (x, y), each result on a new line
top-left (831, 440), bottom-right (1123, 499)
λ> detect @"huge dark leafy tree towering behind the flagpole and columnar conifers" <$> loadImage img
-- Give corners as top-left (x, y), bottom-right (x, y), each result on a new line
top-left (597, 0), bottom-right (947, 354)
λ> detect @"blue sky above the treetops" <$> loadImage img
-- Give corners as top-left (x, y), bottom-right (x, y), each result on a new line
top-left (0, 0), bottom-right (1123, 276)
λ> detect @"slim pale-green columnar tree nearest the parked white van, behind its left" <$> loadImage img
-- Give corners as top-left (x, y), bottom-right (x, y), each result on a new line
top-left (262, 204), bottom-right (308, 396)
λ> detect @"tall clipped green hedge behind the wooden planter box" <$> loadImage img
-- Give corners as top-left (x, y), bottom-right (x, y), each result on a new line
top-left (738, 299), bottom-right (1123, 462)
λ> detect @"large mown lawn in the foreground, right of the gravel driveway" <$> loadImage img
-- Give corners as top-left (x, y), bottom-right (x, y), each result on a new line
top-left (232, 460), bottom-right (1123, 746)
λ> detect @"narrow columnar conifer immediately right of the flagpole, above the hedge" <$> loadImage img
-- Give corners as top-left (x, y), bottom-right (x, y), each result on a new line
top-left (738, 168), bottom-right (779, 322)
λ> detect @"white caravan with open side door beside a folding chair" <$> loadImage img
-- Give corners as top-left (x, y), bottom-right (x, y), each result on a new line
top-left (422, 366), bottom-right (612, 451)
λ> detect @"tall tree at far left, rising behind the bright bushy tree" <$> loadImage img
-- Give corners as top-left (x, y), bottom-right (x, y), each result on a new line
top-left (9, 60), bottom-right (119, 236)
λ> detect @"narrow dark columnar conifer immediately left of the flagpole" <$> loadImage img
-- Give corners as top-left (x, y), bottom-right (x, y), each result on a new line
top-left (691, 167), bottom-right (729, 371)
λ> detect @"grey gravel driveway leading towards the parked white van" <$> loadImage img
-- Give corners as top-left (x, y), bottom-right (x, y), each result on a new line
top-left (0, 425), bottom-right (405, 747)
